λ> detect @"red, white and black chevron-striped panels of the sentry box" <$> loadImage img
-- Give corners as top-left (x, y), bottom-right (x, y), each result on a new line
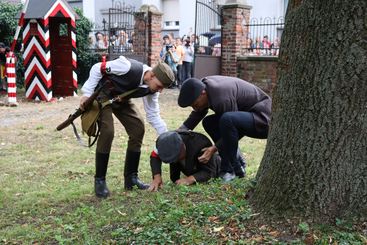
top-left (23, 0), bottom-right (78, 101)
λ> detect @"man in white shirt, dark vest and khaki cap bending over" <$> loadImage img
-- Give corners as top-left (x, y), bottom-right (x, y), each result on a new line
top-left (80, 56), bottom-right (175, 198)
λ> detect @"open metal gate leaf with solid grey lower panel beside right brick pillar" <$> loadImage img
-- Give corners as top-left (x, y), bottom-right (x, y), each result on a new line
top-left (194, 0), bottom-right (222, 78)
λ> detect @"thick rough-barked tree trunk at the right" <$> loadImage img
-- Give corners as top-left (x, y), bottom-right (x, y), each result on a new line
top-left (253, 0), bottom-right (367, 220)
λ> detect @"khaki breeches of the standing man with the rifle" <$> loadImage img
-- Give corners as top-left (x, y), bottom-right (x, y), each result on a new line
top-left (96, 100), bottom-right (145, 153)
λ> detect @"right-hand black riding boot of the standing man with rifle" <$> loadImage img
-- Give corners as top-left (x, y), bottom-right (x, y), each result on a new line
top-left (124, 150), bottom-right (149, 190)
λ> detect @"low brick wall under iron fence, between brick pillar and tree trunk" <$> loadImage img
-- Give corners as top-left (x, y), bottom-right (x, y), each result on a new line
top-left (237, 56), bottom-right (278, 94)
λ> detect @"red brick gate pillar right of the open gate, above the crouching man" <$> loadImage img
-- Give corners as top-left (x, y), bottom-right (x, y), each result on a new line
top-left (221, 1), bottom-right (251, 77)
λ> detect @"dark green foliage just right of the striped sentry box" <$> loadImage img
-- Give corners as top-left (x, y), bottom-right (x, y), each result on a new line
top-left (75, 9), bottom-right (101, 85)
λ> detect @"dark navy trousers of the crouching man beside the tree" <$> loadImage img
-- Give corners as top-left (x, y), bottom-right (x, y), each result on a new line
top-left (203, 111), bottom-right (268, 172)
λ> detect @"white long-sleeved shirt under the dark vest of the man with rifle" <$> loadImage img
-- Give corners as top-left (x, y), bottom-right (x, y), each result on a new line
top-left (81, 56), bottom-right (167, 135)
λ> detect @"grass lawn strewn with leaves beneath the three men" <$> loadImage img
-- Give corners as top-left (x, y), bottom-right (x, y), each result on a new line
top-left (0, 91), bottom-right (367, 244)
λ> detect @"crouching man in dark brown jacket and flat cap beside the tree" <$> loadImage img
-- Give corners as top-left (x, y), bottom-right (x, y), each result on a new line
top-left (178, 76), bottom-right (271, 182)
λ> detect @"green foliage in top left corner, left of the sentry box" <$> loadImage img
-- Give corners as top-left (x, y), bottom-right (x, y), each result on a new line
top-left (0, 1), bottom-right (22, 46)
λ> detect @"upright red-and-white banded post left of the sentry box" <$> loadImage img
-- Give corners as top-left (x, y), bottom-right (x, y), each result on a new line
top-left (5, 51), bottom-right (17, 104)
